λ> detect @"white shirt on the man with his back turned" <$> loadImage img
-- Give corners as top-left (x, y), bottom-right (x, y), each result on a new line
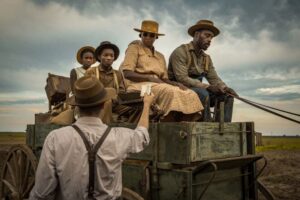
top-left (29, 117), bottom-right (150, 200)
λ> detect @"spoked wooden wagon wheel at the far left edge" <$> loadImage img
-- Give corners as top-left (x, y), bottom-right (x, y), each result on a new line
top-left (0, 145), bottom-right (37, 200)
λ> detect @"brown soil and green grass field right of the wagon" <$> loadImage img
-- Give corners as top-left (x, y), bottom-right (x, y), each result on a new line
top-left (257, 137), bottom-right (300, 200)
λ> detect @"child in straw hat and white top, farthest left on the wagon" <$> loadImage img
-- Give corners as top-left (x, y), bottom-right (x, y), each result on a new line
top-left (70, 46), bottom-right (96, 93)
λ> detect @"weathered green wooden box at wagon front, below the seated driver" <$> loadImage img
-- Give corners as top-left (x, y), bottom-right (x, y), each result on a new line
top-left (115, 122), bottom-right (254, 164)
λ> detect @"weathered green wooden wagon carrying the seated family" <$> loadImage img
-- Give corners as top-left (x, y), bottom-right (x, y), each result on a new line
top-left (0, 75), bottom-right (273, 200)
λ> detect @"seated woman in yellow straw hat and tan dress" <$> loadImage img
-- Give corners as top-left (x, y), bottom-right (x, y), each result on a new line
top-left (121, 20), bottom-right (203, 121)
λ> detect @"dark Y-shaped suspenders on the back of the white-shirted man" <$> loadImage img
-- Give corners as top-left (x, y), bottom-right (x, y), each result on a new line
top-left (72, 124), bottom-right (111, 199)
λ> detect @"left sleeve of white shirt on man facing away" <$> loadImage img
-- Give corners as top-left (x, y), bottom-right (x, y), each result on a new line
top-left (29, 132), bottom-right (58, 200)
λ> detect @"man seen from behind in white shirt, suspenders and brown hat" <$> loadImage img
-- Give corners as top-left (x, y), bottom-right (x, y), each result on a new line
top-left (29, 76), bottom-right (153, 200)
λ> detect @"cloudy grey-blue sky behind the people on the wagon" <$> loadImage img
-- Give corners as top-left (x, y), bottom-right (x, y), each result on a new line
top-left (0, 0), bottom-right (300, 135)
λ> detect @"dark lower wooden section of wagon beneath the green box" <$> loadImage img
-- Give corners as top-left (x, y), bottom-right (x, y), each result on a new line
top-left (122, 157), bottom-right (259, 200)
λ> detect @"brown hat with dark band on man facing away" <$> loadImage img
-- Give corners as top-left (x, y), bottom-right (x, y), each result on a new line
top-left (68, 76), bottom-right (116, 107)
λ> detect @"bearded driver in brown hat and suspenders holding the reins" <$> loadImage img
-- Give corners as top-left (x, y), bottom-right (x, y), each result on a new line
top-left (168, 20), bottom-right (238, 122)
